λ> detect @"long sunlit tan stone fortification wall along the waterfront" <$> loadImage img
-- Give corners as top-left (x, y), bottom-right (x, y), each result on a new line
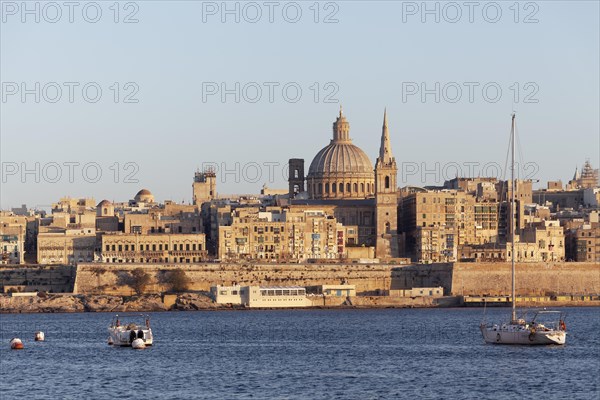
top-left (62, 263), bottom-right (600, 296)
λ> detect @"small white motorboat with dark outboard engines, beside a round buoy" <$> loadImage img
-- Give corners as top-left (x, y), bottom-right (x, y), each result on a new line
top-left (108, 314), bottom-right (153, 348)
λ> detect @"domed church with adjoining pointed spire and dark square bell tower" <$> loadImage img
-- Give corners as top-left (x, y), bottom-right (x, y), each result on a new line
top-left (289, 108), bottom-right (398, 259)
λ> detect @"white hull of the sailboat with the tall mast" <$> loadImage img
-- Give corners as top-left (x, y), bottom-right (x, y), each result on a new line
top-left (481, 325), bottom-right (567, 345)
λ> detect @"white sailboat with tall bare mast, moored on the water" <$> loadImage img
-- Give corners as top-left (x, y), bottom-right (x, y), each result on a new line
top-left (479, 113), bottom-right (567, 345)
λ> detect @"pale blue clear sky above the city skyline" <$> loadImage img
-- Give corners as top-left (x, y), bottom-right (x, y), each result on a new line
top-left (0, 1), bottom-right (600, 209)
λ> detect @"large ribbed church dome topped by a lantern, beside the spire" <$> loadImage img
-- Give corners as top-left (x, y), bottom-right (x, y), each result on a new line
top-left (306, 108), bottom-right (375, 199)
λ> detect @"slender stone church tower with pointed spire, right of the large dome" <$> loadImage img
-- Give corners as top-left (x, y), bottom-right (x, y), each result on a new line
top-left (375, 110), bottom-right (398, 258)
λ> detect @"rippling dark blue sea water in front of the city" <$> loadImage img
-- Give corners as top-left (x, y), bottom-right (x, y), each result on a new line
top-left (0, 308), bottom-right (600, 400)
